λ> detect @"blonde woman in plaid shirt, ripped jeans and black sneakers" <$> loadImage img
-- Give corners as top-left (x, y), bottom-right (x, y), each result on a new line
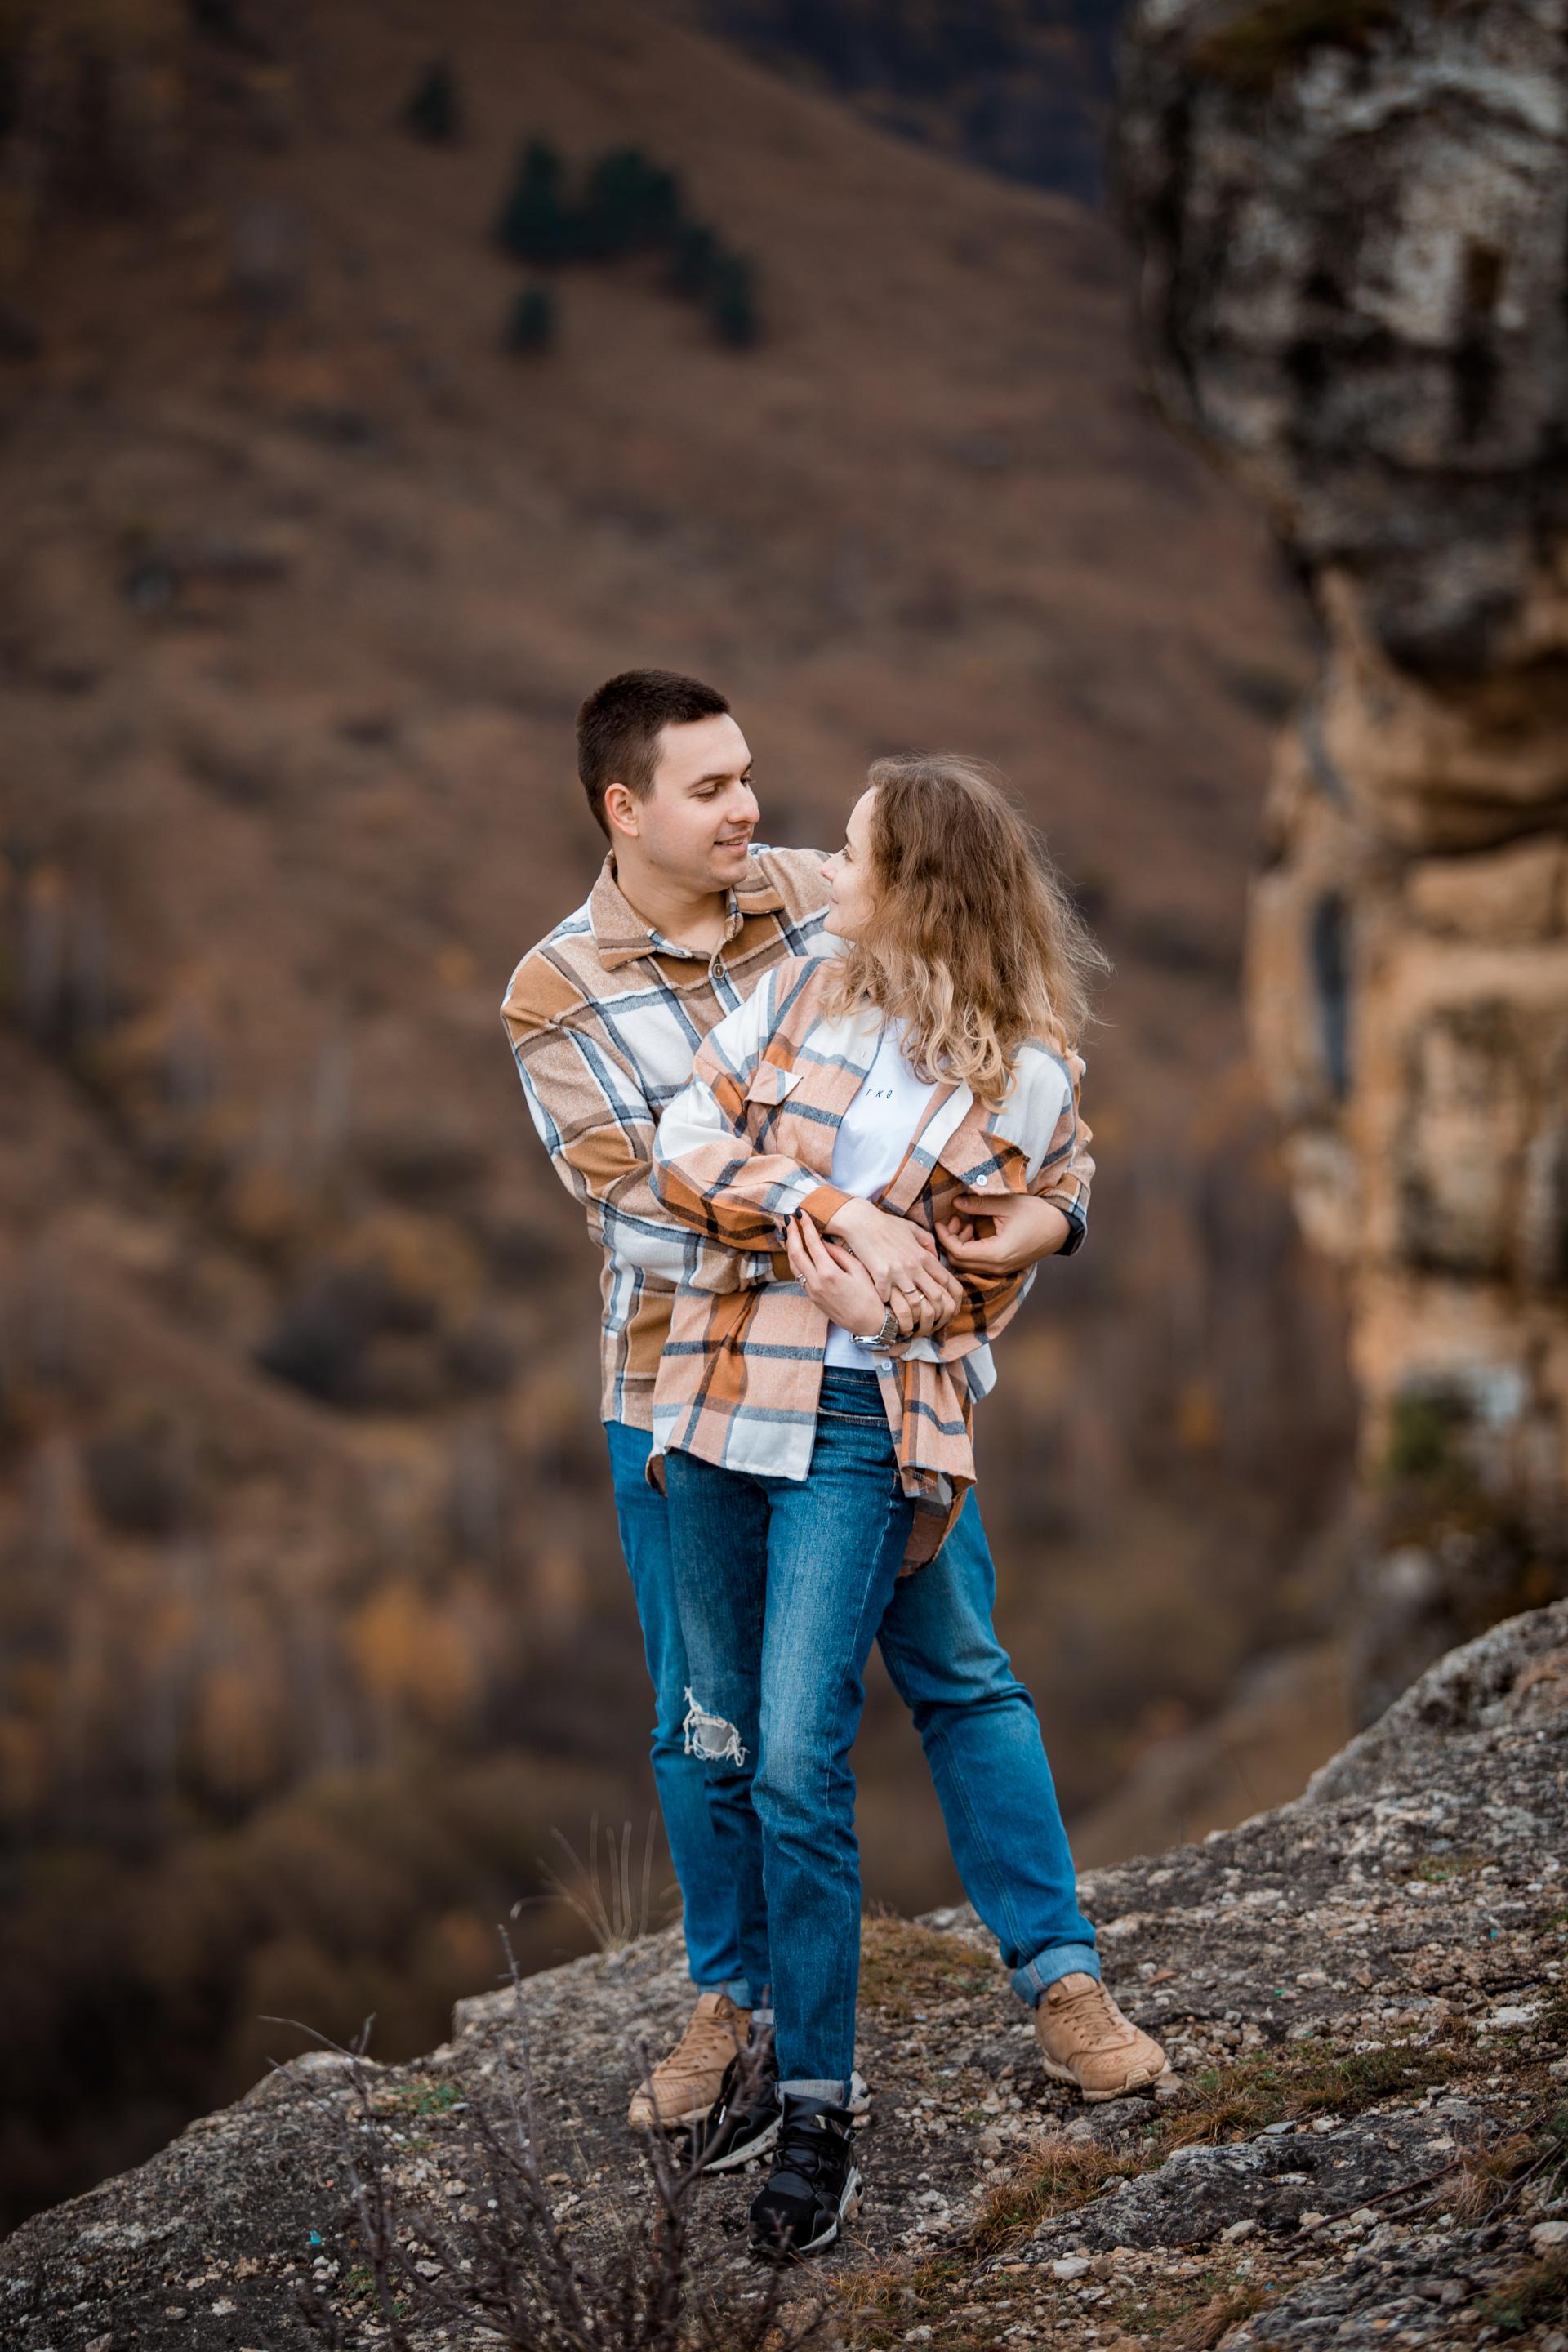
top-left (653, 757), bottom-right (1114, 2253)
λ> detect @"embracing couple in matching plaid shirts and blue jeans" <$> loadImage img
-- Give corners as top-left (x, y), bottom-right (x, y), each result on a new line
top-left (503, 670), bottom-right (1164, 2256)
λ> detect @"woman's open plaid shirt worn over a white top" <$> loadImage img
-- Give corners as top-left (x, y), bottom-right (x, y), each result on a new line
top-left (653, 957), bottom-right (1094, 1566)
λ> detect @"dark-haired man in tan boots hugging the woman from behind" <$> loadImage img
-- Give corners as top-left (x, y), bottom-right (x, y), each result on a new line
top-left (501, 670), bottom-right (1164, 2166)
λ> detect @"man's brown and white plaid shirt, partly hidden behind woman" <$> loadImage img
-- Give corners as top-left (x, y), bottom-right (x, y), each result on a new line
top-left (501, 849), bottom-right (1094, 1430)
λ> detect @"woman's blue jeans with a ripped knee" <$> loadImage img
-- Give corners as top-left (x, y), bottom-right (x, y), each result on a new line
top-left (666, 1369), bottom-right (912, 2096)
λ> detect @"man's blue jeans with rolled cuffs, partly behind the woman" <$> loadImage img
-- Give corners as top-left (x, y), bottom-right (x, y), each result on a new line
top-left (604, 1421), bottom-right (1100, 2007)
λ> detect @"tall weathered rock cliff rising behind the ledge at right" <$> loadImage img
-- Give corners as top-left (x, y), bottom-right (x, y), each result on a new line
top-left (1119, 0), bottom-right (1568, 1694)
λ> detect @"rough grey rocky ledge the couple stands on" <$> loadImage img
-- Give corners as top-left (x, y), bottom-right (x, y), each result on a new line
top-left (0, 1604), bottom-right (1568, 2352)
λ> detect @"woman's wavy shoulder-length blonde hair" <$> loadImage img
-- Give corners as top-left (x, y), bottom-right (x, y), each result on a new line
top-left (832, 753), bottom-right (1112, 1103)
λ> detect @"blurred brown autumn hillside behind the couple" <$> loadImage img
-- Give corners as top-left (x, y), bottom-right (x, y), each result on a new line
top-left (0, 0), bottom-right (1349, 2216)
